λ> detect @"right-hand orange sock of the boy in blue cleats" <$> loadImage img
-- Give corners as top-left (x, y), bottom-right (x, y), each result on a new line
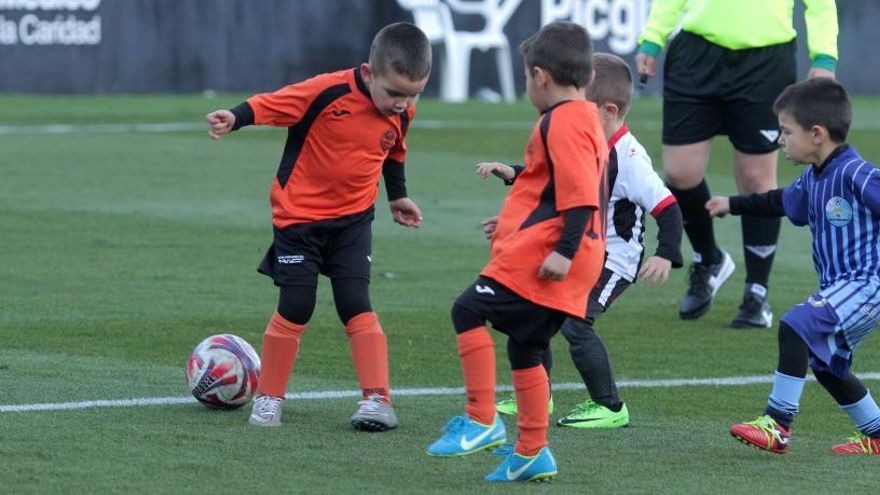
top-left (513, 364), bottom-right (550, 456)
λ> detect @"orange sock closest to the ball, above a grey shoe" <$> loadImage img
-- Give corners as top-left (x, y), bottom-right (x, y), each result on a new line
top-left (257, 312), bottom-right (306, 397)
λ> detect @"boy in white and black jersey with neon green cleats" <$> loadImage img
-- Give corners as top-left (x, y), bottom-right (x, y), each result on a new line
top-left (477, 53), bottom-right (682, 428)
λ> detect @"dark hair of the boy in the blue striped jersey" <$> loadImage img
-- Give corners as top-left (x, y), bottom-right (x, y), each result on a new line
top-left (773, 77), bottom-right (852, 143)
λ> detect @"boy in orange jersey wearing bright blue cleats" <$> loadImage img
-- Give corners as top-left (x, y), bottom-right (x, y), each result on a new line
top-left (428, 22), bottom-right (608, 481)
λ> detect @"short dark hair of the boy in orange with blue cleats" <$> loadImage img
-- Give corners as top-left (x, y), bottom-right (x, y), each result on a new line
top-left (519, 21), bottom-right (593, 88)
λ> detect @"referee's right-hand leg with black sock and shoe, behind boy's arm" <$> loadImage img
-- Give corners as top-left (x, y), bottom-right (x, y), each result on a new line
top-left (731, 149), bottom-right (780, 328)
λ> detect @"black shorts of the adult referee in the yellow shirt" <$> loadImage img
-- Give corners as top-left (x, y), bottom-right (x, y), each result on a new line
top-left (663, 31), bottom-right (797, 154)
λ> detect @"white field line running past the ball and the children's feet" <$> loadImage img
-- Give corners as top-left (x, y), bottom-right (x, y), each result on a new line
top-left (0, 372), bottom-right (880, 413)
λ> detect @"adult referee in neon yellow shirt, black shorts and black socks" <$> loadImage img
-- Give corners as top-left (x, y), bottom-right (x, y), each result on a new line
top-left (636, 0), bottom-right (838, 328)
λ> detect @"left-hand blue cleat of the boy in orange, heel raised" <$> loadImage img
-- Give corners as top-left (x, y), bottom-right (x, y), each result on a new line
top-left (428, 414), bottom-right (507, 457)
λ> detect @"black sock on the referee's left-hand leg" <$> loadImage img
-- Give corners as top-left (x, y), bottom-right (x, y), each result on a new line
top-left (666, 180), bottom-right (721, 265)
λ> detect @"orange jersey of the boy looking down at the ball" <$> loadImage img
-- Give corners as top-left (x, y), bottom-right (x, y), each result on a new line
top-left (247, 69), bottom-right (415, 229)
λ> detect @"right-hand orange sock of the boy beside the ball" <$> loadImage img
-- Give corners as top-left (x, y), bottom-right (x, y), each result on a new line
top-left (345, 312), bottom-right (391, 402)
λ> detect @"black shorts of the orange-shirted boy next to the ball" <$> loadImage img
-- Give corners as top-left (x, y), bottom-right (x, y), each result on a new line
top-left (257, 208), bottom-right (374, 287)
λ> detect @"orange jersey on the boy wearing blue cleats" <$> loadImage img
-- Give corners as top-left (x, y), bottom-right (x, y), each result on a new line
top-left (481, 100), bottom-right (608, 318)
